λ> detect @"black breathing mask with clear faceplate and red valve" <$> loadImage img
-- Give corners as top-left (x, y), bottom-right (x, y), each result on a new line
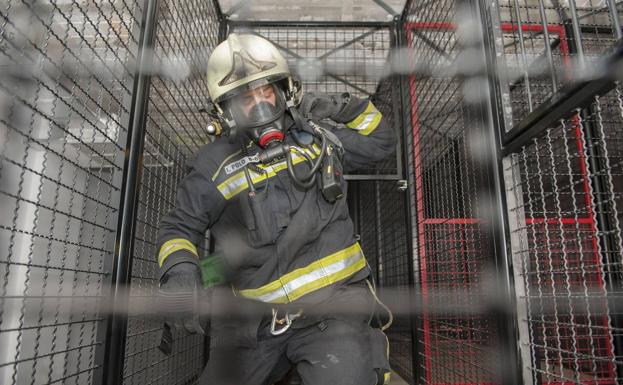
top-left (226, 84), bottom-right (286, 148)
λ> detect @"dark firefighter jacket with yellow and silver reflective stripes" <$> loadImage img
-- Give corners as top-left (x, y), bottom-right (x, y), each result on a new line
top-left (157, 93), bottom-right (395, 318)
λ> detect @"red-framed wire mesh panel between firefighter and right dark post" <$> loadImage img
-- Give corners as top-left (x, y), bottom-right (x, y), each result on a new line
top-left (405, 1), bottom-right (504, 384)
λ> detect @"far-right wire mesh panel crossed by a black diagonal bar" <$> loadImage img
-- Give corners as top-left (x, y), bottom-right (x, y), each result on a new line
top-left (499, 0), bottom-right (621, 384)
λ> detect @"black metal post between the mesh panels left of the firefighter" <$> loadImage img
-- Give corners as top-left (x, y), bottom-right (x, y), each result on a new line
top-left (103, 0), bottom-right (159, 385)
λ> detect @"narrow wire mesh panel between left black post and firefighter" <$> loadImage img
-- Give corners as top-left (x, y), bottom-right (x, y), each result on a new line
top-left (124, 0), bottom-right (219, 385)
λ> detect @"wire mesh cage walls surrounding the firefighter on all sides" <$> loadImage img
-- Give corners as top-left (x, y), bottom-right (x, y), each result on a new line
top-left (0, 0), bottom-right (623, 385)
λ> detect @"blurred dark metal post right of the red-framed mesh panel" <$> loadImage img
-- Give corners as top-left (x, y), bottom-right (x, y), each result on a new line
top-left (466, 0), bottom-right (523, 384)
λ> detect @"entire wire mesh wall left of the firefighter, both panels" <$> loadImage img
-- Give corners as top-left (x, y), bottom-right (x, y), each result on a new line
top-left (0, 0), bottom-right (220, 384)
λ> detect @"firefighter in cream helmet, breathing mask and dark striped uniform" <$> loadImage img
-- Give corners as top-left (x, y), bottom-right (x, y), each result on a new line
top-left (157, 34), bottom-right (395, 385)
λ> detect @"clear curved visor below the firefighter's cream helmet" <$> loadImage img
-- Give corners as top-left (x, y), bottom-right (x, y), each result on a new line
top-left (227, 84), bottom-right (286, 127)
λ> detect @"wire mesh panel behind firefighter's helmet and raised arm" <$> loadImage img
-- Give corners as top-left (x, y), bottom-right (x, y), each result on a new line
top-left (233, 23), bottom-right (400, 179)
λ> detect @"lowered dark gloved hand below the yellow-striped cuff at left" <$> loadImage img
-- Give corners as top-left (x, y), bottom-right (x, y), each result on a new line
top-left (158, 262), bottom-right (205, 334)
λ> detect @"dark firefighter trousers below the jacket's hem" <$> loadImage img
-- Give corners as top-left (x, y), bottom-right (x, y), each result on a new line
top-left (199, 318), bottom-right (389, 385)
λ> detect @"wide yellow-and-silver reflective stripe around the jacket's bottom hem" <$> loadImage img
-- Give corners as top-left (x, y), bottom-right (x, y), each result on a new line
top-left (239, 243), bottom-right (366, 303)
